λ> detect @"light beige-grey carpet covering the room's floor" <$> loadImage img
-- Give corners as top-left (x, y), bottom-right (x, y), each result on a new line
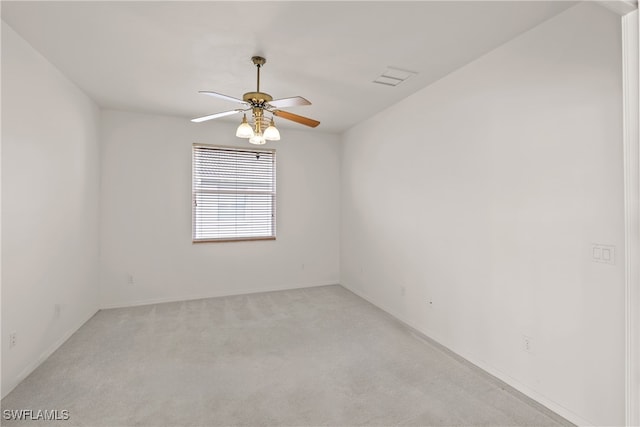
top-left (2, 285), bottom-right (571, 427)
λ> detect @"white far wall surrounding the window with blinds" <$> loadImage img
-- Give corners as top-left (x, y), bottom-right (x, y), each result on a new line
top-left (100, 110), bottom-right (340, 307)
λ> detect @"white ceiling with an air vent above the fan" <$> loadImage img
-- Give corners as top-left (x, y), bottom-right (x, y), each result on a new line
top-left (1, 1), bottom-right (575, 132)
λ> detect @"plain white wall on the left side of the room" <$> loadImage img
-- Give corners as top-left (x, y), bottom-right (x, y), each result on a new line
top-left (2, 22), bottom-right (99, 396)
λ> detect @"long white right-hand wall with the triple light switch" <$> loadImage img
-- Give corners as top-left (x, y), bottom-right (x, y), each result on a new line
top-left (341, 3), bottom-right (624, 425)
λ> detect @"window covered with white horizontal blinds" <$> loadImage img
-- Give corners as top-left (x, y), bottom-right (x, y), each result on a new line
top-left (193, 144), bottom-right (276, 242)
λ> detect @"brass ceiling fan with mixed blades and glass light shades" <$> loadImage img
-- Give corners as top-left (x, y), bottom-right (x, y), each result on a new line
top-left (191, 56), bottom-right (320, 145)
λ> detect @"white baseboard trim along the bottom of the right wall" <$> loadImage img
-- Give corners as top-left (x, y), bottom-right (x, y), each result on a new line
top-left (340, 284), bottom-right (597, 426)
